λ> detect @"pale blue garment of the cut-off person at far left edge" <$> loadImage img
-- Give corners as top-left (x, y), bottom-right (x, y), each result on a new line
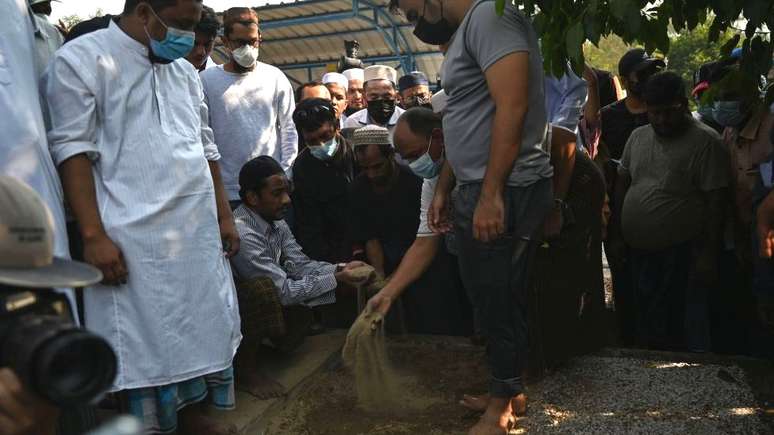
top-left (0, 0), bottom-right (70, 304)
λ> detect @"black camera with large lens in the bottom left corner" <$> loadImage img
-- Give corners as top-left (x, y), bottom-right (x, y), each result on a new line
top-left (0, 284), bottom-right (117, 406)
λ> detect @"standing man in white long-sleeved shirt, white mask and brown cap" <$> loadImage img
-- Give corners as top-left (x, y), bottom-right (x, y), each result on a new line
top-left (201, 7), bottom-right (298, 207)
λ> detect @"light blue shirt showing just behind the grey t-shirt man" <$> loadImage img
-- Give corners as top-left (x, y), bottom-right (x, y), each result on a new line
top-left (545, 70), bottom-right (587, 131)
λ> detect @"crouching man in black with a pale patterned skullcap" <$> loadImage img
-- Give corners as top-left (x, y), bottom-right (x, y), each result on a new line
top-left (350, 125), bottom-right (422, 276)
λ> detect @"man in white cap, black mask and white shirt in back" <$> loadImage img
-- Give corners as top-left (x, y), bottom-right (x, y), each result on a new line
top-left (344, 65), bottom-right (404, 135)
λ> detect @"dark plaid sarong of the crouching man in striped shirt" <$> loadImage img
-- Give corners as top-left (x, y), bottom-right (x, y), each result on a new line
top-left (237, 276), bottom-right (287, 345)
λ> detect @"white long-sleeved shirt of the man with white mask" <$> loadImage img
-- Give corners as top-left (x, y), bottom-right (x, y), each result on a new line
top-left (200, 62), bottom-right (298, 201)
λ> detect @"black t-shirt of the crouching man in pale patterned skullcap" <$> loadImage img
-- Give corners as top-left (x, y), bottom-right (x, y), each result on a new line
top-left (350, 164), bottom-right (422, 273)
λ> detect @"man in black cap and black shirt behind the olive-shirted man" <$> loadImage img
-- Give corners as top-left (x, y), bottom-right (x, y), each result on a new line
top-left (596, 48), bottom-right (666, 344)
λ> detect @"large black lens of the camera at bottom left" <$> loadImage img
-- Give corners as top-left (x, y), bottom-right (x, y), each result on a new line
top-left (2, 315), bottom-right (117, 405)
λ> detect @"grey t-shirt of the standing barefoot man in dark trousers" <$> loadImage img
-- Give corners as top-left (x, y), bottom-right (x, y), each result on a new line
top-left (442, 0), bottom-right (553, 186)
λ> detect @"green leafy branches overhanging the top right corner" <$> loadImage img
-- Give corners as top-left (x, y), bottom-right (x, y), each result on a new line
top-left (496, 0), bottom-right (774, 89)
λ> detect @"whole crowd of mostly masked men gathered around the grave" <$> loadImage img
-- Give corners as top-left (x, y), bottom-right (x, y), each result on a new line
top-left (0, 0), bottom-right (774, 435)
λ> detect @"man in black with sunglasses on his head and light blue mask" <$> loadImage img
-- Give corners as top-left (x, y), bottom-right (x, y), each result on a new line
top-left (293, 98), bottom-right (355, 264)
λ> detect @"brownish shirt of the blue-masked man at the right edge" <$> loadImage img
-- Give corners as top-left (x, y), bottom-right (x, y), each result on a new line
top-left (723, 109), bottom-right (774, 227)
